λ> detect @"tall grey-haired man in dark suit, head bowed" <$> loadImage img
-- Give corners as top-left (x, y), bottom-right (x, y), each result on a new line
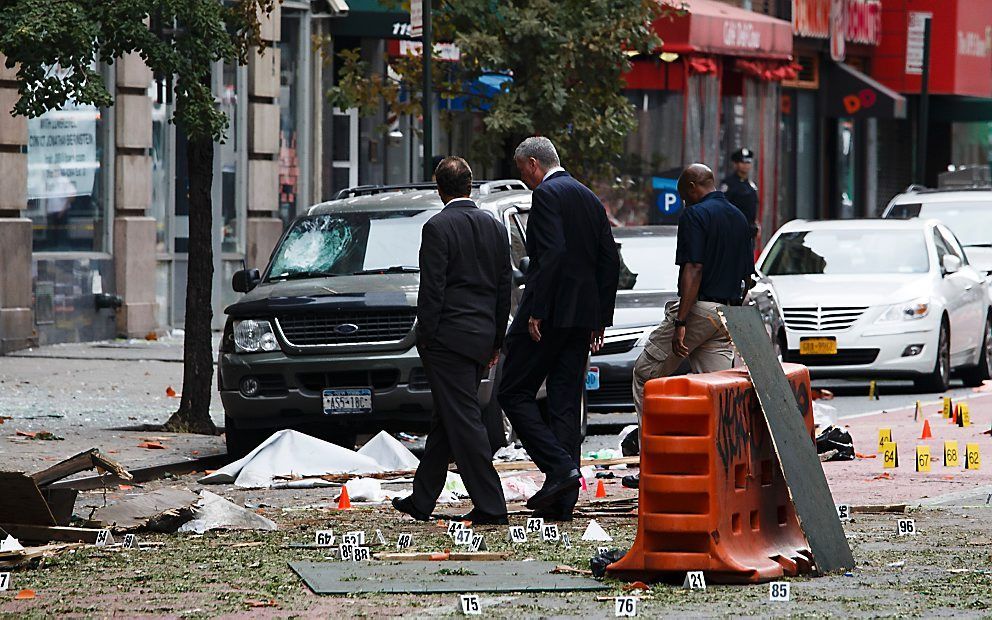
top-left (499, 138), bottom-right (620, 521)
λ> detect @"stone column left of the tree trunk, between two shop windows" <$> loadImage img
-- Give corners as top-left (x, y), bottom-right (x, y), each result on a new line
top-left (114, 54), bottom-right (158, 338)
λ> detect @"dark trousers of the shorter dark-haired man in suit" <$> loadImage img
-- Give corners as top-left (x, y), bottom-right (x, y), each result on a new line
top-left (412, 345), bottom-right (506, 515)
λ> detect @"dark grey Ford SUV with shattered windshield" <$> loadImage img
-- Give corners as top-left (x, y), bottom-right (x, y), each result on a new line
top-left (218, 181), bottom-right (585, 456)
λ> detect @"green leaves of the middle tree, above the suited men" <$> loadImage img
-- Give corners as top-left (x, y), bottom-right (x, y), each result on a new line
top-left (329, 0), bottom-right (663, 179)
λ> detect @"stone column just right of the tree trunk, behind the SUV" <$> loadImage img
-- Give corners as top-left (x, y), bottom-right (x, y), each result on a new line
top-left (245, 4), bottom-right (282, 269)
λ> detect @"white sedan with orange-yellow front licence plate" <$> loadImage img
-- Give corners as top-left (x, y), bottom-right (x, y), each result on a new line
top-left (758, 219), bottom-right (992, 392)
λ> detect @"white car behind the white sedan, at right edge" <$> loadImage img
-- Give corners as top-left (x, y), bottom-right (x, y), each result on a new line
top-left (882, 186), bottom-right (992, 274)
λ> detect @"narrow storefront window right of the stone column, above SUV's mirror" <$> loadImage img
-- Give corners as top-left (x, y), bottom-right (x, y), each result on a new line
top-left (279, 11), bottom-right (300, 223)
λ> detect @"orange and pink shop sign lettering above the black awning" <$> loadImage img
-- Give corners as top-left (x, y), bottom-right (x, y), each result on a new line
top-left (792, 0), bottom-right (882, 46)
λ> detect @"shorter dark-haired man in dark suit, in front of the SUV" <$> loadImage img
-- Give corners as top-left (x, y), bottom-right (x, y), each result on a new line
top-left (393, 157), bottom-right (511, 524)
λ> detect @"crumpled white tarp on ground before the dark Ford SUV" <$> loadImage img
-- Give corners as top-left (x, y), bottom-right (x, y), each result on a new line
top-left (200, 430), bottom-right (389, 489)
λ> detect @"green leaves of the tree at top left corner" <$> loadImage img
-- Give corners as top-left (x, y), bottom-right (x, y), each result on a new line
top-left (0, 0), bottom-right (275, 141)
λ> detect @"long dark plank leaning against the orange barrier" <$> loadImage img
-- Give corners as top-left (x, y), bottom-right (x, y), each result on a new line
top-left (719, 306), bottom-right (854, 573)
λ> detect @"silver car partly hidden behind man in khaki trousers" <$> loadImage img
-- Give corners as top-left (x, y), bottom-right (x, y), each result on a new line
top-left (587, 226), bottom-right (785, 412)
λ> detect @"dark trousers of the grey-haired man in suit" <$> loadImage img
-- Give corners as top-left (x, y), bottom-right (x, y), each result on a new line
top-left (499, 328), bottom-right (591, 514)
